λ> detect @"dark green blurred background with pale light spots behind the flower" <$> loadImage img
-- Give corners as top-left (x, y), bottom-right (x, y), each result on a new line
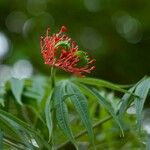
top-left (0, 0), bottom-right (150, 84)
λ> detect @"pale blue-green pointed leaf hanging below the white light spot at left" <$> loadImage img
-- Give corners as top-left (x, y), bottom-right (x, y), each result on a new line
top-left (10, 78), bottom-right (24, 105)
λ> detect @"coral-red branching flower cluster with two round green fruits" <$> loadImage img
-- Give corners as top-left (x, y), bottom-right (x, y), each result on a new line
top-left (40, 26), bottom-right (95, 76)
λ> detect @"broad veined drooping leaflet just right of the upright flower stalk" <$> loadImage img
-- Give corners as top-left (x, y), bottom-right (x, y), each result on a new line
top-left (53, 81), bottom-right (77, 148)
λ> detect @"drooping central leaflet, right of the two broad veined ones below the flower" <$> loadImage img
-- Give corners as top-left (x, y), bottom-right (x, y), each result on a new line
top-left (66, 81), bottom-right (94, 144)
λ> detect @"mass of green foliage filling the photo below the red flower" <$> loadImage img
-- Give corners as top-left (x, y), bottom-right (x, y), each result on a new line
top-left (0, 75), bottom-right (150, 149)
